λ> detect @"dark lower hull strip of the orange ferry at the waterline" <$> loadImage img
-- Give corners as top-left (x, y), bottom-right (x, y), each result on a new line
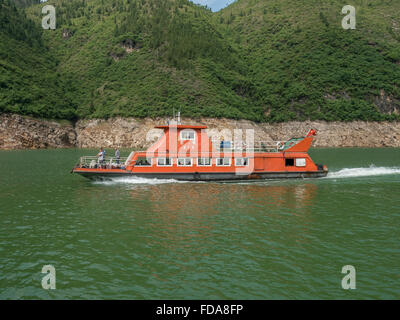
top-left (74, 170), bottom-right (328, 181)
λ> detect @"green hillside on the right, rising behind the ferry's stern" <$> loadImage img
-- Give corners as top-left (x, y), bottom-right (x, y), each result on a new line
top-left (218, 0), bottom-right (400, 121)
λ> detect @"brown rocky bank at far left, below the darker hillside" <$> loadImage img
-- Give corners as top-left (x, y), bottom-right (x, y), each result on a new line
top-left (0, 114), bottom-right (76, 149)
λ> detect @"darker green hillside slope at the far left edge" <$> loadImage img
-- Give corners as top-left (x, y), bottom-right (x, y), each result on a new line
top-left (0, 0), bottom-right (76, 119)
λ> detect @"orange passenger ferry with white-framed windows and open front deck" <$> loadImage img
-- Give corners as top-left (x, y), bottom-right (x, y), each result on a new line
top-left (71, 118), bottom-right (328, 181)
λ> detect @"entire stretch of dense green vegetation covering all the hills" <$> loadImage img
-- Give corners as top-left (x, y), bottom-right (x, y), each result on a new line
top-left (0, 0), bottom-right (400, 121)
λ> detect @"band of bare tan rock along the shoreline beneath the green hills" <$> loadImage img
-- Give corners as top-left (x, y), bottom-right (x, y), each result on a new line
top-left (0, 114), bottom-right (400, 150)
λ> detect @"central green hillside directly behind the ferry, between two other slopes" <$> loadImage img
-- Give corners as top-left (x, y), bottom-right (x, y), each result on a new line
top-left (23, 0), bottom-right (259, 120)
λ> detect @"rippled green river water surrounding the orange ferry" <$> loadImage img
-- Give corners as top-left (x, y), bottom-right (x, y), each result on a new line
top-left (0, 149), bottom-right (400, 299)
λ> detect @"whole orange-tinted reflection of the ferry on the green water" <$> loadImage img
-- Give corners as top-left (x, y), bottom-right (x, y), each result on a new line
top-left (130, 183), bottom-right (317, 272)
